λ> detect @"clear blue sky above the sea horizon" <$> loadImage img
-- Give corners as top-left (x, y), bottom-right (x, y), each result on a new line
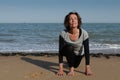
top-left (0, 0), bottom-right (120, 23)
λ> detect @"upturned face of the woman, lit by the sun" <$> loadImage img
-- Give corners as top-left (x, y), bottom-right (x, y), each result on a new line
top-left (69, 14), bottom-right (78, 28)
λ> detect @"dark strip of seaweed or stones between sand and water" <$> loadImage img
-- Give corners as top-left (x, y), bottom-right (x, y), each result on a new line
top-left (0, 52), bottom-right (120, 58)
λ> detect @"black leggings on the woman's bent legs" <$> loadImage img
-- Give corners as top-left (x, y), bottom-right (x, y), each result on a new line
top-left (61, 45), bottom-right (83, 68)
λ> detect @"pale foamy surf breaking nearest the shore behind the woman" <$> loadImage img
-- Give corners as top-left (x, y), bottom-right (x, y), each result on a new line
top-left (0, 43), bottom-right (120, 54)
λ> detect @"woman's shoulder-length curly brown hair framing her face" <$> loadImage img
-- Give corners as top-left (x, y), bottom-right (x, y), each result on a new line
top-left (64, 12), bottom-right (82, 30)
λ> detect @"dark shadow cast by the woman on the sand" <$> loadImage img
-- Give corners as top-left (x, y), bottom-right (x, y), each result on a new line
top-left (21, 57), bottom-right (85, 74)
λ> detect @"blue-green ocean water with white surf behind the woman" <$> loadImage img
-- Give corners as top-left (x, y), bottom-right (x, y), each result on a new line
top-left (0, 23), bottom-right (120, 54)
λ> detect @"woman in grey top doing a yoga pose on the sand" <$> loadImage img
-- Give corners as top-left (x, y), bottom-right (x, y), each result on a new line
top-left (57, 12), bottom-right (92, 76)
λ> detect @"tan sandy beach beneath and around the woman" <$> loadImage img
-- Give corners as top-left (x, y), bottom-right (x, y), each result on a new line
top-left (0, 54), bottom-right (120, 80)
